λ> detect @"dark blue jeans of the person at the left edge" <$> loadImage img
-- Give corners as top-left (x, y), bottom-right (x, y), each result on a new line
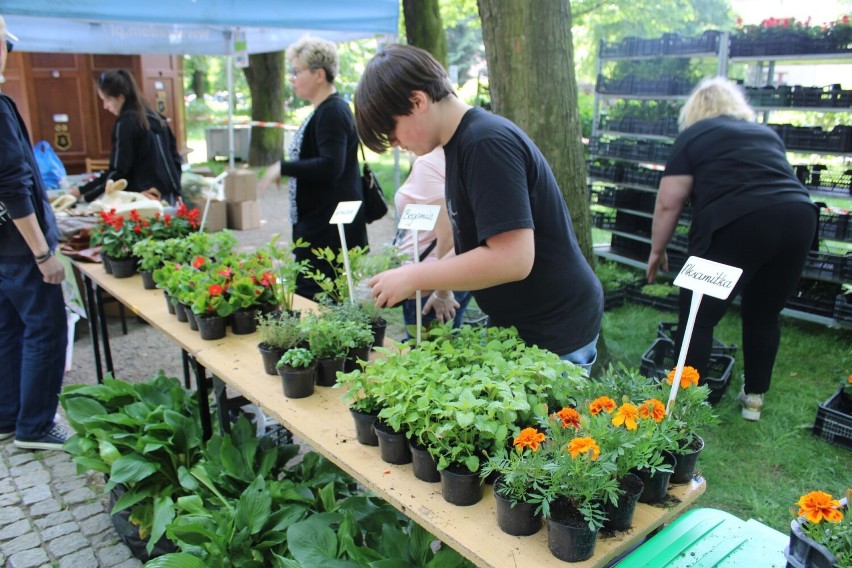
top-left (0, 256), bottom-right (68, 440)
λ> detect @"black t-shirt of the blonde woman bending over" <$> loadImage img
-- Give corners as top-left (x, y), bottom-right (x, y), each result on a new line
top-left (663, 116), bottom-right (812, 255)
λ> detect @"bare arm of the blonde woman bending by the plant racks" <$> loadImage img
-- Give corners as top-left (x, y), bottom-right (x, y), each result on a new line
top-left (645, 175), bottom-right (694, 282)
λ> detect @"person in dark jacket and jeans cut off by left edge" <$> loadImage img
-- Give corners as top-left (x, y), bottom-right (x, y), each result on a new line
top-left (0, 16), bottom-right (68, 450)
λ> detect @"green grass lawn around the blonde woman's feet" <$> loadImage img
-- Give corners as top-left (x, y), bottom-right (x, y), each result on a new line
top-left (603, 304), bottom-right (852, 534)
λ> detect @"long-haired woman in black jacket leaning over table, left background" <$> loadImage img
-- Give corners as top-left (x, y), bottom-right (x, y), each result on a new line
top-left (71, 69), bottom-right (181, 204)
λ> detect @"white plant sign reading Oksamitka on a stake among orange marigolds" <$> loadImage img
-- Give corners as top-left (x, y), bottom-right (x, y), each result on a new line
top-left (666, 256), bottom-right (743, 415)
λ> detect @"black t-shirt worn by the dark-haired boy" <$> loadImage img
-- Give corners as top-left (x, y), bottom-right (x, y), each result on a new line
top-left (444, 108), bottom-right (603, 355)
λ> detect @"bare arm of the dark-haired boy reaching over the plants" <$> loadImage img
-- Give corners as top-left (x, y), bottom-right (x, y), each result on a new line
top-left (368, 229), bottom-right (535, 307)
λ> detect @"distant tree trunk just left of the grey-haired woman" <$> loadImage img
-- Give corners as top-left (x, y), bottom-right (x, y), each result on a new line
top-left (243, 51), bottom-right (284, 166)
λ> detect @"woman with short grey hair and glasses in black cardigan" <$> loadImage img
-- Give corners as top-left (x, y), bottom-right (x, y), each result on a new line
top-left (261, 37), bottom-right (367, 298)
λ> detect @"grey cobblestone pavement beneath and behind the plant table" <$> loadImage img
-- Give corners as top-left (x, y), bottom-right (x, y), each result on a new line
top-left (0, 170), bottom-right (395, 568)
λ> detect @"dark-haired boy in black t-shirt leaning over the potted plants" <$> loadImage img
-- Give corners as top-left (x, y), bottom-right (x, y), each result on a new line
top-left (355, 45), bottom-right (603, 368)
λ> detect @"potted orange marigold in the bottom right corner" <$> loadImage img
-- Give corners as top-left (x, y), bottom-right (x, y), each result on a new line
top-left (784, 489), bottom-right (852, 568)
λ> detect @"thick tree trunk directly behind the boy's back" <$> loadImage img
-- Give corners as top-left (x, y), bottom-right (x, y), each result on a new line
top-left (478, 0), bottom-right (594, 266)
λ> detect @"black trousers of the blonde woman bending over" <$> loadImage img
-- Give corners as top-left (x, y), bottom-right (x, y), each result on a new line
top-left (677, 203), bottom-right (817, 394)
